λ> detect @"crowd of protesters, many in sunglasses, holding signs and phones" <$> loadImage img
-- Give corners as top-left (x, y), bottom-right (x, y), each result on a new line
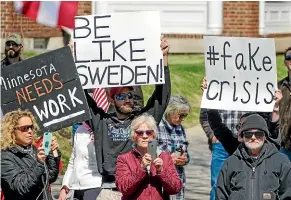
top-left (1, 33), bottom-right (291, 200)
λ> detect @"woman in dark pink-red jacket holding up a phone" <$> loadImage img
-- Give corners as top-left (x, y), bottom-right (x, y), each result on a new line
top-left (116, 115), bottom-right (182, 200)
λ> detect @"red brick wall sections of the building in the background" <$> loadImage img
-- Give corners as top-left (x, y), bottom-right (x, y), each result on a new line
top-left (1, 1), bottom-right (291, 39)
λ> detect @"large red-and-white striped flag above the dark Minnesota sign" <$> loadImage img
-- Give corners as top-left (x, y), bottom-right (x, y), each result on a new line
top-left (14, 1), bottom-right (78, 28)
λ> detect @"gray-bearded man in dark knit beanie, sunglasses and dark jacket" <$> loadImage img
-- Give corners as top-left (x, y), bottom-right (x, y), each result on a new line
top-left (216, 114), bottom-right (291, 200)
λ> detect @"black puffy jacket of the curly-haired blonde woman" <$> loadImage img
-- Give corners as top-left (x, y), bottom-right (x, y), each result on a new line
top-left (1, 146), bottom-right (60, 200)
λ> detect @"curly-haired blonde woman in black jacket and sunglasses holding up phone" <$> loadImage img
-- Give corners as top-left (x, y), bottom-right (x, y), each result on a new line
top-left (1, 110), bottom-right (60, 200)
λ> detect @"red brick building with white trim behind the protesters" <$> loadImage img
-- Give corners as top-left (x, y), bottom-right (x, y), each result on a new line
top-left (1, 1), bottom-right (291, 53)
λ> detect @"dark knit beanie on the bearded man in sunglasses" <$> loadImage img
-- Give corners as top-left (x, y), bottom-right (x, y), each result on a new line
top-left (241, 114), bottom-right (269, 137)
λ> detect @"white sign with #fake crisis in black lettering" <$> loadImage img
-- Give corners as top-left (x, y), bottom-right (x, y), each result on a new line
top-left (201, 36), bottom-right (277, 112)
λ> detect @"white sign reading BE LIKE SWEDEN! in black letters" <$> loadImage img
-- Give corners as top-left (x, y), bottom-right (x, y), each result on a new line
top-left (73, 11), bottom-right (164, 89)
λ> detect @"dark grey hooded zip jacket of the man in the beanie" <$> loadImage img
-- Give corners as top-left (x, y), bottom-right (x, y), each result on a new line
top-left (216, 141), bottom-right (291, 200)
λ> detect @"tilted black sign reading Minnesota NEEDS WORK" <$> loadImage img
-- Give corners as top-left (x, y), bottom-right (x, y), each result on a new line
top-left (0, 47), bottom-right (90, 131)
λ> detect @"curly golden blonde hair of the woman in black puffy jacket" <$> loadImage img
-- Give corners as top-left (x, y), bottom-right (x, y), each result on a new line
top-left (0, 109), bottom-right (39, 150)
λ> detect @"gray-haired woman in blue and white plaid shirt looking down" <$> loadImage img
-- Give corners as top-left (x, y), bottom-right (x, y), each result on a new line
top-left (158, 94), bottom-right (191, 200)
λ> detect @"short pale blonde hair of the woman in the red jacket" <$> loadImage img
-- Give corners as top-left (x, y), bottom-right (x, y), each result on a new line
top-left (130, 114), bottom-right (158, 140)
